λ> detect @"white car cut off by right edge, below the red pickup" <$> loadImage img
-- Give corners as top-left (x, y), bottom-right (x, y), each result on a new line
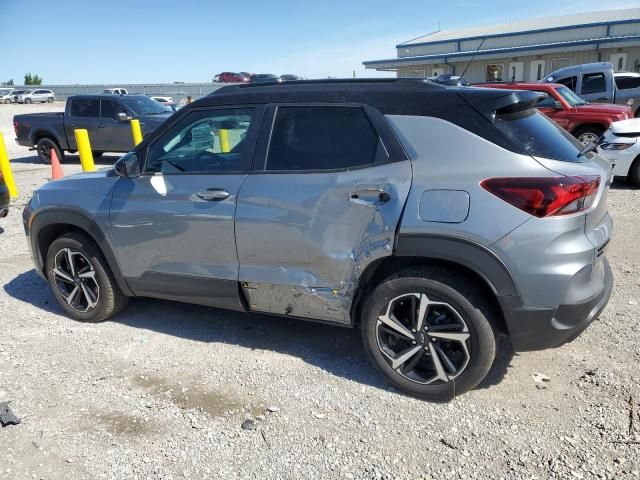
top-left (598, 118), bottom-right (640, 186)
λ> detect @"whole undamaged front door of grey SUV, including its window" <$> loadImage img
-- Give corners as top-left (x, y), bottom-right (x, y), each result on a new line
top-left (110, 107), bottom-right (261, 309)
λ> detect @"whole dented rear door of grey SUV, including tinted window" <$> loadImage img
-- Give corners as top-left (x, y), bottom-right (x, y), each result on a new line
top-left (236, 105), bottom-right (411, 323)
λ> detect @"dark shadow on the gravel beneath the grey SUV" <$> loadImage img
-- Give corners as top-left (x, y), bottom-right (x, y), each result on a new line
top-left (4, 270), bottom-right (513, 392)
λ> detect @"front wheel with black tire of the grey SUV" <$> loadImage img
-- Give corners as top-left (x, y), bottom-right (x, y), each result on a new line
top-left (46, 233), bottom-right (129, 323)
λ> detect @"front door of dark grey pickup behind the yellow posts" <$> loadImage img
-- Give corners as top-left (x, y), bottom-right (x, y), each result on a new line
top-left (91, 99), bottom-right (134, 152)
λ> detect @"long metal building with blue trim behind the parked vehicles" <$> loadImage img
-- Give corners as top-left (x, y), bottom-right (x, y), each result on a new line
top-left (363, 8), bottom-right (640, 82)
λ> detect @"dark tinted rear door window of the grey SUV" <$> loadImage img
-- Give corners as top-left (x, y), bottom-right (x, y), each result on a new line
top-left (267, 106), bottom-right (378, 170)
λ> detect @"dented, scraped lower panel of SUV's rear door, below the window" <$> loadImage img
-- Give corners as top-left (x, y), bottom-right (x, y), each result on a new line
top-left (236, 161), bottom-right (411, 323)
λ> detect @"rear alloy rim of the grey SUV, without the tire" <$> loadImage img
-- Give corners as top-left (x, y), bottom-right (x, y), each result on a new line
top-left (376, 293), bottom-right (471, 385)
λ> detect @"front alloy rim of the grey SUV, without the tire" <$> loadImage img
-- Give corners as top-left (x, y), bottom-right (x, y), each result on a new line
top-left (51, 248), bottom-right (100, 313)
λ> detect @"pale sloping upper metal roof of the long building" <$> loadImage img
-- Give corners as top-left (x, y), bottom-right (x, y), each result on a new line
top-left (397, 8), bottom-right (640, 48)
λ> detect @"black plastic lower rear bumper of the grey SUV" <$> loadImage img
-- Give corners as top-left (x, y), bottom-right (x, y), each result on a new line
top-left (500, 257), bottom-right (613, 351)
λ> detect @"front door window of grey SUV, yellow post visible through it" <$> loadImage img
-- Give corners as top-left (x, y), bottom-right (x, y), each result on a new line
top-left (145, 108), bottom-right (255, 173)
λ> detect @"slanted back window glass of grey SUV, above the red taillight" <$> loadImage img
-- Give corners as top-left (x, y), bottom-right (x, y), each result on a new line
top-left (494, 109), bottom-right (582, 162)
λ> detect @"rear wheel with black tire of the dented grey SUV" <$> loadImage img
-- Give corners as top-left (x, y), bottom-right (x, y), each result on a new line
top-left (361, 267), bottom-right (496, 402)
